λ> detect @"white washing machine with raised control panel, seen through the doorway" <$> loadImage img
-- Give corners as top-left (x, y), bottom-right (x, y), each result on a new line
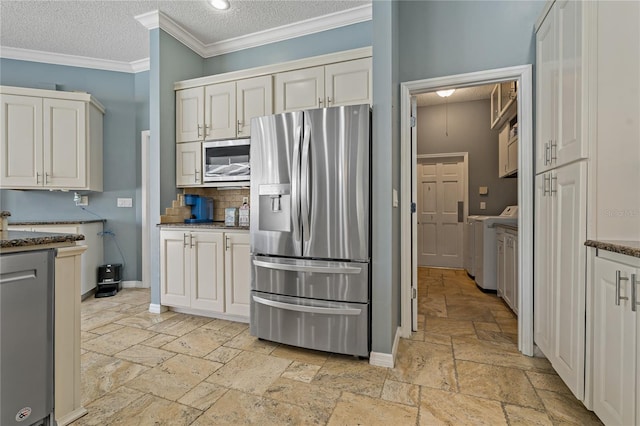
top-left (469, 206), bottom-right (518, 291)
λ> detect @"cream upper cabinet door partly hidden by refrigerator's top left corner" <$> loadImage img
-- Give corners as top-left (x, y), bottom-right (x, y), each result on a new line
top-left (236, 75), bottom-right (273, 138)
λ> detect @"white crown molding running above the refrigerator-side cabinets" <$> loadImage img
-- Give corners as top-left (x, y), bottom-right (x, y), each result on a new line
top-left (200, 4), bottom-right (372, 58)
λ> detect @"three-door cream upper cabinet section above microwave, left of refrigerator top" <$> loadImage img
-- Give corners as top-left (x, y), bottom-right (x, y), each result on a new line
top-left (176, 75), bottom-right (273, 143)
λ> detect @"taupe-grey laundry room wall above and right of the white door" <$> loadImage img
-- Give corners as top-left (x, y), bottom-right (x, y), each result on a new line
top-left (418, 99), bottom-right (518, 215)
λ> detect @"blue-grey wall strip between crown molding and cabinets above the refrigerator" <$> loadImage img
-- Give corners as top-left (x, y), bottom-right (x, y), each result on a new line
top-left (204, 21), bottom-right (372, 75)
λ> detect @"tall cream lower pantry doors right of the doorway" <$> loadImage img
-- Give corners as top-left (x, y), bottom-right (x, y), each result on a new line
top-left (534, 161), bottom-right (587, 400)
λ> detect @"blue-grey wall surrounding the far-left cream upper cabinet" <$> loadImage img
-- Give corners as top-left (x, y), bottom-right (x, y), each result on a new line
top-left (0, 59), bottom-right (148, 280)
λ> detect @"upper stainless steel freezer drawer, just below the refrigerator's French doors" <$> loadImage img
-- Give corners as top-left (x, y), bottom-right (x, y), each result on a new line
top-left (251, 256), bottom-right (369, 303)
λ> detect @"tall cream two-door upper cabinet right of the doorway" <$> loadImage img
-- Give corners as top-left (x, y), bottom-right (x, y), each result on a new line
top-left (536, 0), bottom-right (588, 173)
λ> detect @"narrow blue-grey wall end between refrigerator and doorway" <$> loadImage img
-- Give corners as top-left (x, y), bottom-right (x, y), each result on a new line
top-left (371, 1), bottom-right (400, 353)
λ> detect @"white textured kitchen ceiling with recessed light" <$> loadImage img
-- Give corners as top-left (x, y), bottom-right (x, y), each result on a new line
top-left (0, 0), bottom-right (371, 62)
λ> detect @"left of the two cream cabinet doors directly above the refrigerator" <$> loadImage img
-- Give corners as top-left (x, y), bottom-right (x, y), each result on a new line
top-left (274, 67), bottom-right (326, 114)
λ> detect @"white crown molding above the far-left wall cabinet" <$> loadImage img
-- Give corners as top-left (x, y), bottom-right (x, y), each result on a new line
top-left (0, 46), bottom-right (149, 73)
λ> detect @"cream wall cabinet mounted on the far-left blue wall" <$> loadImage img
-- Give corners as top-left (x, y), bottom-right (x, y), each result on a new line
top-left (0, 86), bottom-right (104, 191)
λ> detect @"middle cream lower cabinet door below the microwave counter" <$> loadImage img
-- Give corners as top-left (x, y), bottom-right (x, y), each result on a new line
top-left (189, 232), bottom-right (224, 312)
